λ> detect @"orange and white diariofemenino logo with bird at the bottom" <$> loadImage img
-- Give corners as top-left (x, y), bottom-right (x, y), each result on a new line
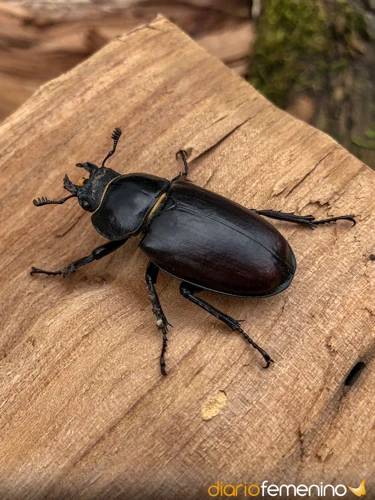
top-left (208, 479), bottom-right (366, 498)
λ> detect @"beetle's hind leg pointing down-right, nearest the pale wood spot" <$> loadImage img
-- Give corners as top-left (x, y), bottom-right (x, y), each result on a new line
top-left (180, 281), bottom-right (273, 368)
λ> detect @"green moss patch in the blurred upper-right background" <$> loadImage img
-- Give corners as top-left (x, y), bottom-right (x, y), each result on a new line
top-left (248, 0), bottom-right (367, 107)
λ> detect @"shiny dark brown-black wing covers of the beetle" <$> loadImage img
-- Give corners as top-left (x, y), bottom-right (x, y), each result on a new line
top-left (140, 180), bottom-right (296, 297)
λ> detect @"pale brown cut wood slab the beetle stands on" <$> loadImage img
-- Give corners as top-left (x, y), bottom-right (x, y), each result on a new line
top-left (0, 13), bottom-right (375, 499)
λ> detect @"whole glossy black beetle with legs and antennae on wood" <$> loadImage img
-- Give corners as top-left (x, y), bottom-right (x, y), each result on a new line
top-left (31, 128), bottom-right (356, 375)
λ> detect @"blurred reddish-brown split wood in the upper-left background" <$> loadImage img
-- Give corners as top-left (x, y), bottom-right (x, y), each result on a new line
top-left (0, 0), bottom-right (254, 121)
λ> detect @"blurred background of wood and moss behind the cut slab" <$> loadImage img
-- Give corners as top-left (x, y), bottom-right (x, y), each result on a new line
top-left (0, 0), bottom-right (375, 168)
